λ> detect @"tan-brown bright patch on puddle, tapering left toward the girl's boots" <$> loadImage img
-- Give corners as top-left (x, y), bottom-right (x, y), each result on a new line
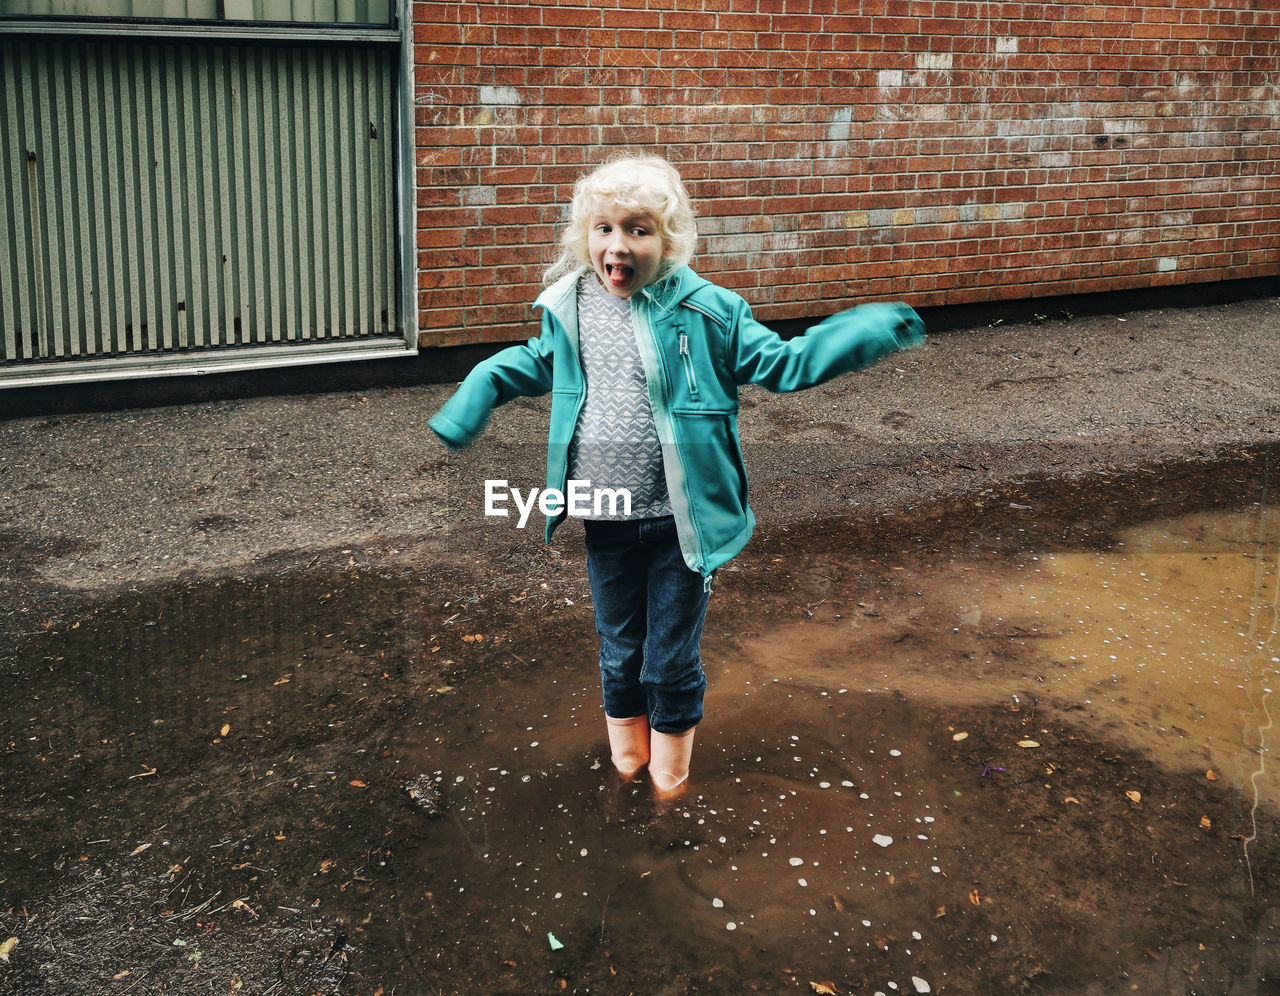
top-left (745, 496), bottom-right (1280, 801)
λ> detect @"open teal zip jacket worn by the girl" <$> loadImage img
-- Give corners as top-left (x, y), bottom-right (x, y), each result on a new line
top-left (430, 266), bottom-right (924, 579)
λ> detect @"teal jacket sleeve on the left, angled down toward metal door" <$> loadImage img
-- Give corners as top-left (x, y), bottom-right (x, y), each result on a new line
top-left (428, 321), bottom-right (554, 449)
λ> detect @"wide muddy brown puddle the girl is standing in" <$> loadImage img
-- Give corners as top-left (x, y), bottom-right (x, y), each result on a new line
top-left (0, 452), bottom-right (1280, 996)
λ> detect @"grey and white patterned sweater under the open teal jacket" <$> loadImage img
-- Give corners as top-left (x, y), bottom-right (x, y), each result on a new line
top-left (568, 273), bottom-right (671, 520)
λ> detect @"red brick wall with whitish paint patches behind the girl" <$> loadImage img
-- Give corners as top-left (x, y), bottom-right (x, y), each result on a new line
top-left (413, 0), bottom-right (1280, 346)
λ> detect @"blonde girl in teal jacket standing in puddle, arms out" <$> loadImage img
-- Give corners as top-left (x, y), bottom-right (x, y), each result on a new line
top-left (430, 156), bottom-right (924, 796)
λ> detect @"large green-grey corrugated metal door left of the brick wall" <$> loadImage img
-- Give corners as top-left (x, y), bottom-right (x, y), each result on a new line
top-left (0, 38), bottom-right (403, 376)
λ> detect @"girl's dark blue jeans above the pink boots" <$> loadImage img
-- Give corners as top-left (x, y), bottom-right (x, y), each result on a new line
top-left (582, 516), bottom-right (710, 734)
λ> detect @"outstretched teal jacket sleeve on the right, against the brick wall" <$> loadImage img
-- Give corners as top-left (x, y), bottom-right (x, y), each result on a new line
top-left (728, 294), bottom-right (924, 393)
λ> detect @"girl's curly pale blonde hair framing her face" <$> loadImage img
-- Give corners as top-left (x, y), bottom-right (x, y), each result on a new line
top-left (544, 155), bottom-right (698, 284)
